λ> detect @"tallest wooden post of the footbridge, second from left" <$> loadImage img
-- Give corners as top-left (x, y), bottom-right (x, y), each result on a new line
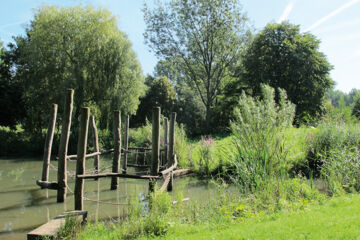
top-left (57, 89), bottom-right (74, 202)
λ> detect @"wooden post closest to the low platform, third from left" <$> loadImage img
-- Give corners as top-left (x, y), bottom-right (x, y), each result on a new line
top-left (74, 107), bottom-right (90, 210)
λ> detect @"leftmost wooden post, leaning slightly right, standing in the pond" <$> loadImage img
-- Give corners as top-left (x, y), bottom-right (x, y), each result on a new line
top-left (41, 104), bottom-right (57, 182)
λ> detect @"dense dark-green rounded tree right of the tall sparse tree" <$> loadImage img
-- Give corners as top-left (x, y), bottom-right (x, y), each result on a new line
top-left (238, 22), bottom-right (334, 120)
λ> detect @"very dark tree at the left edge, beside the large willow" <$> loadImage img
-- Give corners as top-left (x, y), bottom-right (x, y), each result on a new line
top-left (0, 42), bottom-right (24, 128)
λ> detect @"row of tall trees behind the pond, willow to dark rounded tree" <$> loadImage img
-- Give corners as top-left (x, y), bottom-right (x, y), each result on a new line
top-left (0, 0), bottom-right (354, 137)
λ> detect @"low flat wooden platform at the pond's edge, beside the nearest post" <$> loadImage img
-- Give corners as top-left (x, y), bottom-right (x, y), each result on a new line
top-left (27, 211), bottom-right (87, 240)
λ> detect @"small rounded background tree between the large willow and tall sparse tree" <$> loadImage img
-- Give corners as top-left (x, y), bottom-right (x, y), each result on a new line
top-left (134, 76), bottom-right (176, 123)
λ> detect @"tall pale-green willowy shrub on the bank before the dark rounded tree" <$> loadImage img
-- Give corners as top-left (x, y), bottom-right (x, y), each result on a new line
top-left (229, 85), bottom-right (295, 192)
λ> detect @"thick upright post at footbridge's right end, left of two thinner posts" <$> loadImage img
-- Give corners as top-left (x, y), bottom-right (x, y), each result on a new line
top-left (149, 107), bottom-right (160, 191)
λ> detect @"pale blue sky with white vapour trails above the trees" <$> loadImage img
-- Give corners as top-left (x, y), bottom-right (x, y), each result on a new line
top-left (0, 0), bottom-right (360, 92)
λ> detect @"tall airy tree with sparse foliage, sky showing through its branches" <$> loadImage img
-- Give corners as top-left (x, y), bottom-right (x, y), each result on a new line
top-left (144, 0), bottom-right (249, 132)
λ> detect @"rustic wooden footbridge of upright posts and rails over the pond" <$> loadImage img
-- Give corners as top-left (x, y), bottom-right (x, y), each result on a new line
top-left (28, 89), bottom-right (189, 239)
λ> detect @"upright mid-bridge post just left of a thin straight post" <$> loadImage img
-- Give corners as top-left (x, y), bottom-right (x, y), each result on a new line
top-left (110, 111), bottom-right (121, 190)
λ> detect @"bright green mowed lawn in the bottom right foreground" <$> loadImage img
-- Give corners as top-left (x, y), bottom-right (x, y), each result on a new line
top-left (148, 195), bottom-right (360, 239)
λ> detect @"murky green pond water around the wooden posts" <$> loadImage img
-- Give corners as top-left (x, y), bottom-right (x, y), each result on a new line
top-left (0, 159), bottom-right (215, 240)
